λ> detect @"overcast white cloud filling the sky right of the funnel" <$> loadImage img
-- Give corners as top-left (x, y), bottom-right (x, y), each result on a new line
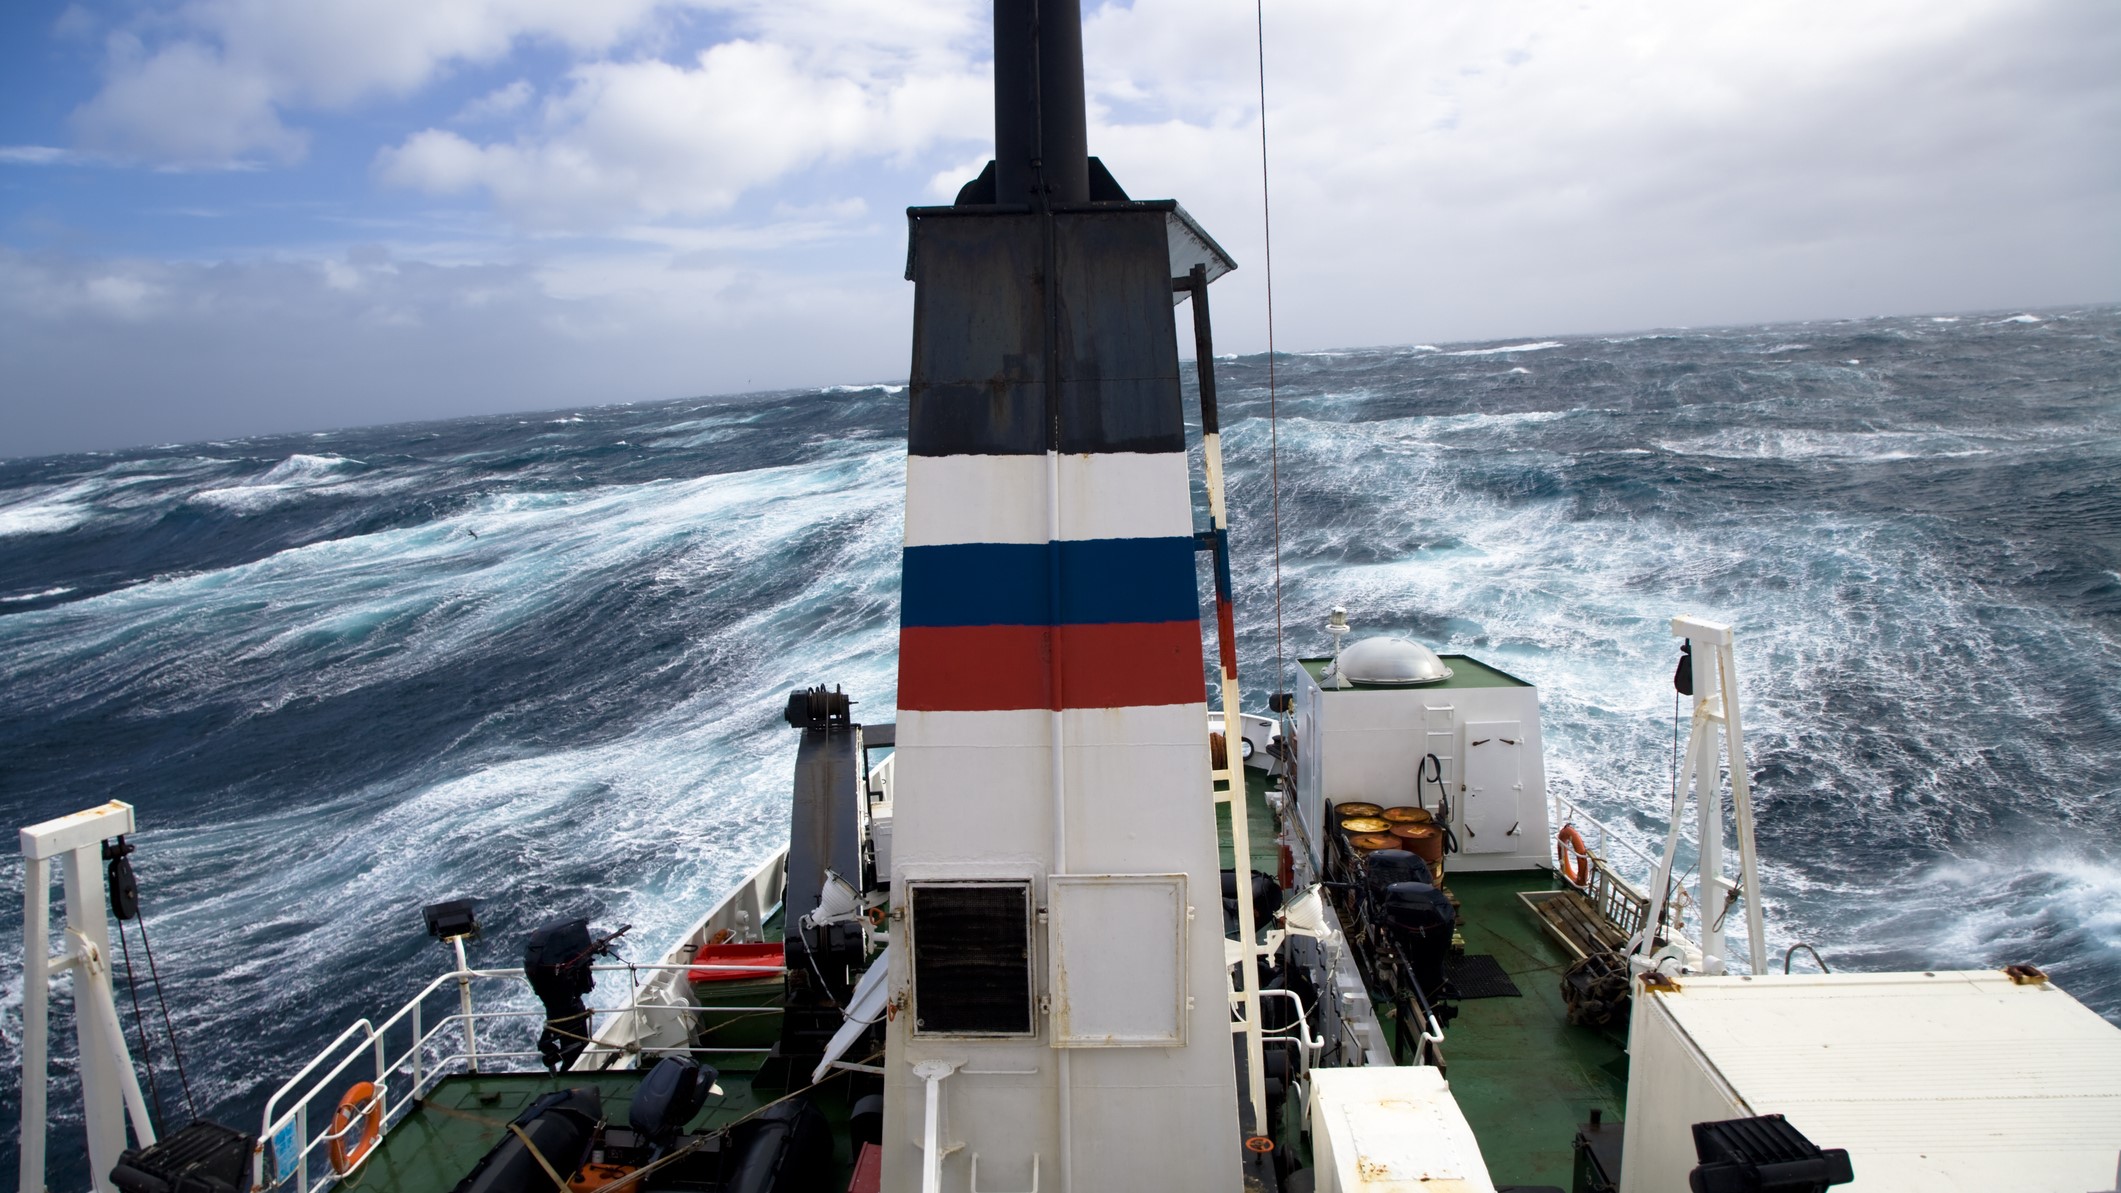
top-left (1086, 0), bottom-right (2121, 346)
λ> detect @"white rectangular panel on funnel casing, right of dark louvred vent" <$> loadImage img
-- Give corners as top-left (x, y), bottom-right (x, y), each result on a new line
top-left (1046, 875), bottom-right (1188, 1049)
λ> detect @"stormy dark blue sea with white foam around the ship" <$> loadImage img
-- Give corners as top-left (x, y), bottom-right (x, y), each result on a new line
top-left (0, 299), bottom-right (2121, 1187)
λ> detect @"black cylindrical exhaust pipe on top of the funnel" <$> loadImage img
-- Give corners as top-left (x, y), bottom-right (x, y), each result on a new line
top-left (995, 0), bottom-right (1090, 208)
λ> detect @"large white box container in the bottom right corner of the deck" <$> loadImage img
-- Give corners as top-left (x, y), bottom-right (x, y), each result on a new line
top-left (1620, 970), bottom-right (2121, 1193)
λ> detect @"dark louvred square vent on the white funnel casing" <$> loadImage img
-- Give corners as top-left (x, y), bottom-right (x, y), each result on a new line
top-left (908, 883), bottom-right (1033, 1036)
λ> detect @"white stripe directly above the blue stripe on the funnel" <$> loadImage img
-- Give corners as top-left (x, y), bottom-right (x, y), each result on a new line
top-left (906, 452), bottom-right (1194, 548)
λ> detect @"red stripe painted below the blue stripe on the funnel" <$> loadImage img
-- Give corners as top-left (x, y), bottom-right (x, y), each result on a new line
top-left (899, 622), bottom-right (1207, 713)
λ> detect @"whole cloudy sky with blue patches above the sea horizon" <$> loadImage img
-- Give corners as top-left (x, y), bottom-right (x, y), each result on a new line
top-left (0, 0), bottom-right (2121, 456)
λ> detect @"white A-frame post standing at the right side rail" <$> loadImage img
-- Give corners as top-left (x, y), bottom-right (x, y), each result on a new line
top-left (1635, 616), bottom-right (1767, 974)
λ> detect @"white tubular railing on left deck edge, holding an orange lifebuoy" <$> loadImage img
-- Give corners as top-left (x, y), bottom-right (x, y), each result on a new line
top-left (250, 964), bottom-right (781, 1193)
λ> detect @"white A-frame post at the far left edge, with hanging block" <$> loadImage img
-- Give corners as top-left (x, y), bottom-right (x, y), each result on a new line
top-left (21, 800), bottom-right (155, 1193)
